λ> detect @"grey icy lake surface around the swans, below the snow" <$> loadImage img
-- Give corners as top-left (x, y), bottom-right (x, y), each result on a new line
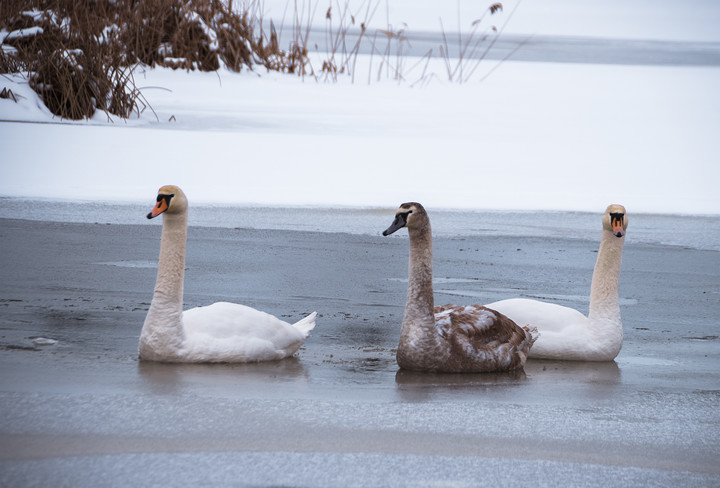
top-left (0, 215), bottom-right (720, 488)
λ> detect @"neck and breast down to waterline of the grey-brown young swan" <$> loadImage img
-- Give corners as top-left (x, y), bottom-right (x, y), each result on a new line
top-left (398, 222), bottom-right (438, 355)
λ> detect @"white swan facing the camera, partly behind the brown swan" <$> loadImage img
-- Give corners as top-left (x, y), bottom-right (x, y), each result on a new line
top-left (486, 205), bottom-right (628, 361)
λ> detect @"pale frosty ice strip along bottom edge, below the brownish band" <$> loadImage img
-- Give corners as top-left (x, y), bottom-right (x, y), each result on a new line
top-left (0, 451), bottom-right (718, 488)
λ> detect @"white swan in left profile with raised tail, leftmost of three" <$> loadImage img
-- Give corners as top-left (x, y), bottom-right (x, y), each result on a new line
top-left (139, 185), bottom-right (316, 363)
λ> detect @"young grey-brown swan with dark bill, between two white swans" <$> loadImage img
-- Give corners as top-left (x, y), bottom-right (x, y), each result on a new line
top-left (383, 202), bottom-right (535, 373)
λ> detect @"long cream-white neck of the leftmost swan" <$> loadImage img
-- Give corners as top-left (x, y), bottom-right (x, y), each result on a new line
top-left (140, 212), bottom-right (187, 359)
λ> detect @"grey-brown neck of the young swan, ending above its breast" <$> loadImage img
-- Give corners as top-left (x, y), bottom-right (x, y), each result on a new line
top-left (401, 222), bottom-right (435, 334)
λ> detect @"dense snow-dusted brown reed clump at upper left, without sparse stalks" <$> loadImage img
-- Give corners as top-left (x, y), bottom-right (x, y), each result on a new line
top-left (0, 0), bottom-right (311, 120)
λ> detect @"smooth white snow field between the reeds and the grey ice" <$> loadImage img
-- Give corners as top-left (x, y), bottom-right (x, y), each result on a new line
top-left (0, 62), bottom-right (720, 214)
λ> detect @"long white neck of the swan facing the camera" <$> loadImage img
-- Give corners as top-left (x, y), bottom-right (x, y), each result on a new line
top-left (588, 230), bottom-right (625, 351)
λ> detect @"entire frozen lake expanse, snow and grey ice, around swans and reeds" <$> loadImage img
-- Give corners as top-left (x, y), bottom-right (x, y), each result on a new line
top-left (0, 0), bottom-right (720, 488)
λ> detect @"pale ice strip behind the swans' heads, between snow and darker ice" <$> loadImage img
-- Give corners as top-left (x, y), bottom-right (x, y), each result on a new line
top-left (0, 196), bottom-right (720, 251)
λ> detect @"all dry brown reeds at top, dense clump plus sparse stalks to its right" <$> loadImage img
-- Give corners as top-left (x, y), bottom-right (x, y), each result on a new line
top-left (0, 0), bottom-right (517, 120)
